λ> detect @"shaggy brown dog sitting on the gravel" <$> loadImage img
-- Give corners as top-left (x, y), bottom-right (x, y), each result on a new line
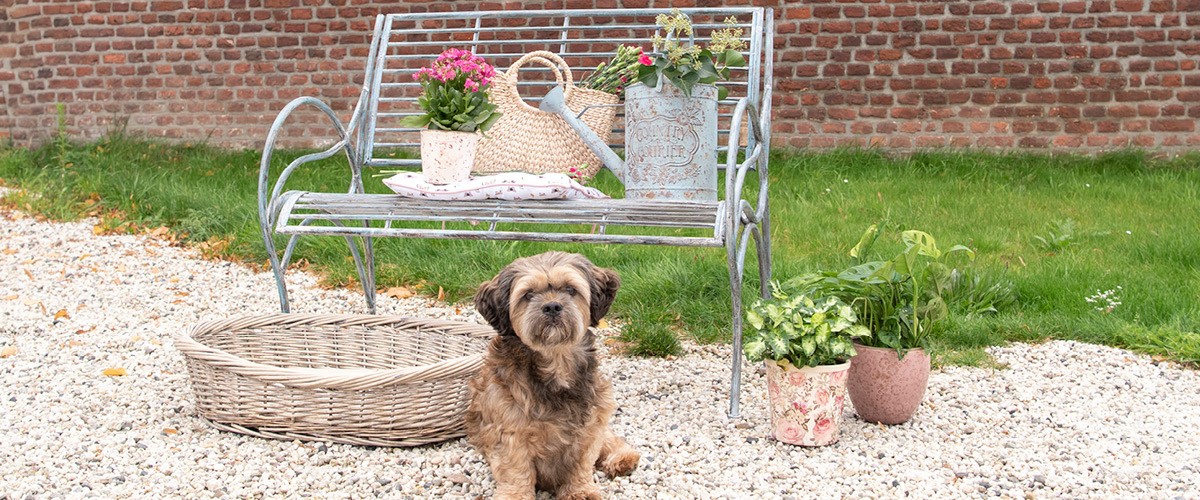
top-left (467, 252), bottom-right (638, 499)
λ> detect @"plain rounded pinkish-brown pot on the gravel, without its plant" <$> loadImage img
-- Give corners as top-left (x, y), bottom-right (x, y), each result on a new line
top-left (846, 344), bottom-right (930, 426)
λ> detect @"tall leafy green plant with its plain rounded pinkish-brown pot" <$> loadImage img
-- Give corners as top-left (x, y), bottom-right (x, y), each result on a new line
top-left (788, 225), bottom-right (974, 424)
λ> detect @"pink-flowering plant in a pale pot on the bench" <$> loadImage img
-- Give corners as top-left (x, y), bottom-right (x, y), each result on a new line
top-left (401, 49), bottom-right (500, 185)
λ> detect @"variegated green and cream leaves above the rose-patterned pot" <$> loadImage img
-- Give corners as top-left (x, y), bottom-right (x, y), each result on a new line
top-left (743, 283), bottom-right (871, 367)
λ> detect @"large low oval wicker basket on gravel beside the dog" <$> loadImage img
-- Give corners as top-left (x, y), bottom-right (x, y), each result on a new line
top-left (175, 314), bottom-right (494, 446)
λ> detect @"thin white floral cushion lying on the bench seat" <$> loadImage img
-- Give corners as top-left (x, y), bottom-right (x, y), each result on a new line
top-left (383, 171), bottom-right (608, 200)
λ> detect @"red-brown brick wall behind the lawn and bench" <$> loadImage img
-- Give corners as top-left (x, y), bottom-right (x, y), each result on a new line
top-left (0, 0), bottom-right (1200, 151)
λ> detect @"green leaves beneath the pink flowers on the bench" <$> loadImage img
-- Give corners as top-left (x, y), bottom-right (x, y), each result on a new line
top-left (401, 79), bottom-right (500, 132)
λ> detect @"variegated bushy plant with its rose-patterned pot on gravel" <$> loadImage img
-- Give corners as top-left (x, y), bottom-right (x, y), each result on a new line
top-left (743, 283), bottom-right (870, 446)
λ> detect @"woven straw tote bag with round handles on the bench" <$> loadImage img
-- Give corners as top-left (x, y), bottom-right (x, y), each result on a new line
top-left (474, 50), bottom-right (618, 177)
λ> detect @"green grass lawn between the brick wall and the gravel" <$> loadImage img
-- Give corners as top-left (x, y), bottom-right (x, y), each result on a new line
top-left (0, 131), bottom-right (1200, 363)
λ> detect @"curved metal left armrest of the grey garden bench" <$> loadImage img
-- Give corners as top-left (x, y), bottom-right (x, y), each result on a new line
top-left (258, 91), bottom-right (367, 231)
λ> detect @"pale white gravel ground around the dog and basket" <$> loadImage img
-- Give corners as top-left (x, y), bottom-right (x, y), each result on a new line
top-left (0, 205), bottom-right (1200, 499)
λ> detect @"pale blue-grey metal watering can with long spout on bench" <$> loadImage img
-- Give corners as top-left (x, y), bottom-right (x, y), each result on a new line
top-left (539, 84), bottom-right (718, 201)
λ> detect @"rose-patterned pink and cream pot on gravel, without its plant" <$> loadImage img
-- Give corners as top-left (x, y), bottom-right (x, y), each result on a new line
top-left (764, 360), bottom-right (850, 446)
